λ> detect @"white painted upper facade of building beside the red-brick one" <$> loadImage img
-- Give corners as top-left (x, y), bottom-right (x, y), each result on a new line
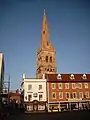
top-left (21, 76), bottom-right (46, 102)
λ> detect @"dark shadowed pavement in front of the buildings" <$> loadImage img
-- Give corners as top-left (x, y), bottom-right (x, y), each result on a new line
top-left (6, 111), bottom-right (90, 120)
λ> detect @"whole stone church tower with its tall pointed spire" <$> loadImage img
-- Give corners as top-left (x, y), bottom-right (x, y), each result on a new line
top-left (36, 10), bottom-right (57, 78)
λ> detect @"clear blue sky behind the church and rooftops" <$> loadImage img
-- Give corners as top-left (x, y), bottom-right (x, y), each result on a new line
top-left (0, 0), bottom-right (90, 89)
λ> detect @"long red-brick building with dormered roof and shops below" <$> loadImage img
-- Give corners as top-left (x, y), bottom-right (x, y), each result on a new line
top-left (46, 74), bottom-right (90, 111)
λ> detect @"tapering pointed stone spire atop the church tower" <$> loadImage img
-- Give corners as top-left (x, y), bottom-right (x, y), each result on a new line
top-left (41, 9), bottom-right (50, 49)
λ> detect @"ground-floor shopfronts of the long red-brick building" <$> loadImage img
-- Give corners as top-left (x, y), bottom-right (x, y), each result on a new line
top-left (48, 101), bottom-right (90, 112)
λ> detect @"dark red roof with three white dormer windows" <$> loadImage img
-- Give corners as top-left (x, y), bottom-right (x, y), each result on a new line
top-left (45, 74), bottom-right (90, 82)
